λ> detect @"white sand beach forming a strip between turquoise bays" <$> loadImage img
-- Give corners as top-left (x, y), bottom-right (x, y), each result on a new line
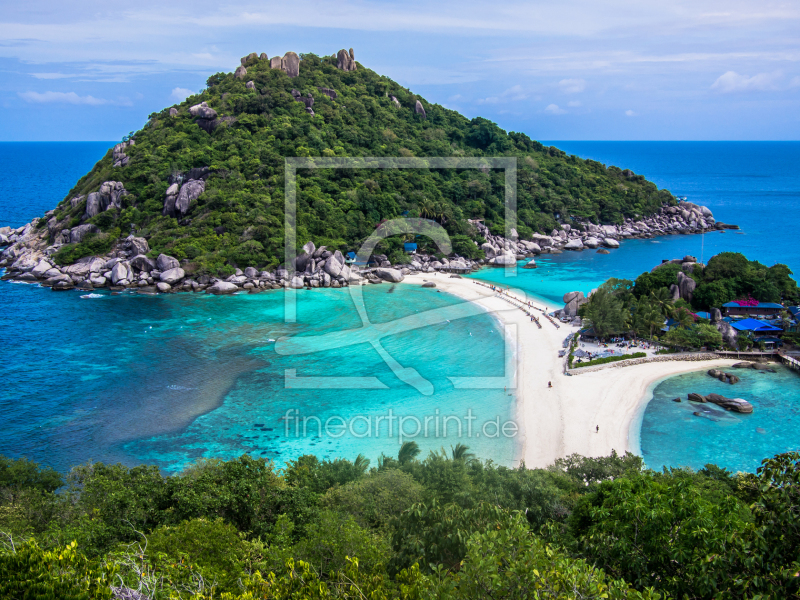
top-left (404, 273), bottom-right (736, 467)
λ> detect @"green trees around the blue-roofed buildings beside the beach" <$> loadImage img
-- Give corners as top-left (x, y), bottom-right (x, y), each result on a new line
top-left (578, 252), bottom-right (800, 349)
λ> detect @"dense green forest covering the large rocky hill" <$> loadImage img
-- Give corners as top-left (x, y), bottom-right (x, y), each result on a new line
top-left (39, 52), bottom-right (674, 272)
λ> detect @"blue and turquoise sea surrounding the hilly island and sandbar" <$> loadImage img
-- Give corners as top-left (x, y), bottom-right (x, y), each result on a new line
top-left (0, 142), bottom-right (800, 471)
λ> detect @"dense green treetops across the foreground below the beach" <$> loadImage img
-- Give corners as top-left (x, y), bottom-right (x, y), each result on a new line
top-left (0, 442), bottom-right (800, 600)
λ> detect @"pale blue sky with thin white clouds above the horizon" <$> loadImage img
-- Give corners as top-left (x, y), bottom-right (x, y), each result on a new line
top-left (0, 0), bottom-right (800, 141)
